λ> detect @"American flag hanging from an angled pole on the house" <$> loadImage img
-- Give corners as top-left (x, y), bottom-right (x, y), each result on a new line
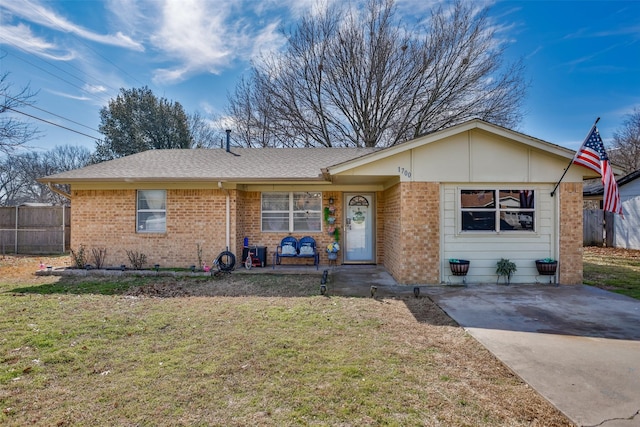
top-left (573, 125), bottom-right (623, 216)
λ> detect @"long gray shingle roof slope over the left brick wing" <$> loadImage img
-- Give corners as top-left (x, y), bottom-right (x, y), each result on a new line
top-left (39, 148), bottom-right (377, 183)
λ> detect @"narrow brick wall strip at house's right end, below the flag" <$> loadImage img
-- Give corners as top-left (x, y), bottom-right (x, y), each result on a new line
top-left (558, 182), bottom-right (583, 285)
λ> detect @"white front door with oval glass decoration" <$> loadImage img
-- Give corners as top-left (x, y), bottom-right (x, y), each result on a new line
top-left (344, 193), bottom-right (376, 264)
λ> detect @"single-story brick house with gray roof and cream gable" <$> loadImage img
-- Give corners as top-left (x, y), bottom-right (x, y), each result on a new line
top-left (39, 120), bottom-right (594, 285)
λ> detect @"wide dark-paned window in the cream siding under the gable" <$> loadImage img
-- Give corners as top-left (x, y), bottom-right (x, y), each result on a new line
top-left (460, 188), bottom-right (536, 232)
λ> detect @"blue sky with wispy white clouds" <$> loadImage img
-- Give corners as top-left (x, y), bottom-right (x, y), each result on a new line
top-left (0, 0), bottom-right (640, 154)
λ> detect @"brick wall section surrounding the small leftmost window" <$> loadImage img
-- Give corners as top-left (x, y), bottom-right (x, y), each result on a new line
top-left (71, 190), bottom-right (230, 267)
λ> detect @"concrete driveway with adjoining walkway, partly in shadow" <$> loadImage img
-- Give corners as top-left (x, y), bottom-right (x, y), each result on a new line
top-left (329, 267), bottom-right (640, 427)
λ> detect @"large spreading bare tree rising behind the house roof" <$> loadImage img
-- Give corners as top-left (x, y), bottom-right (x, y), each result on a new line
top-left (229, 0), bottom-right (526, 147)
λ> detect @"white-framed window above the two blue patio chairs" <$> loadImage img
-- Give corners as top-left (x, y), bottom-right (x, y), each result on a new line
top-left (261, 191), bottom-right (322, 232)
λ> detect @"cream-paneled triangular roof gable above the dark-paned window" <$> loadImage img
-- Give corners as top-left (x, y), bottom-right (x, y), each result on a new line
top-left (328, 120), bottom-right (594, 185)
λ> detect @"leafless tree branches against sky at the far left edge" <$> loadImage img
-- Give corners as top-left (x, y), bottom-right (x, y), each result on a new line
top-left (0, 65), bottom-right (39, 154)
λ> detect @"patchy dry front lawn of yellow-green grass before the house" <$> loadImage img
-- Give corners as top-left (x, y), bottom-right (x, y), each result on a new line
top-left (0, 257), bottom-right (571, 426)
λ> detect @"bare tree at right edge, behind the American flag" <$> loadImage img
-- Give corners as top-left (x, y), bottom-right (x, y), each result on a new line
top-left (609, 107), bottom-right (640, 173)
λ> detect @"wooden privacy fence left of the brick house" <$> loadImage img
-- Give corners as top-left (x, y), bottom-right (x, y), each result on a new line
top-left (0, 206), bottom-right (71, 254)
